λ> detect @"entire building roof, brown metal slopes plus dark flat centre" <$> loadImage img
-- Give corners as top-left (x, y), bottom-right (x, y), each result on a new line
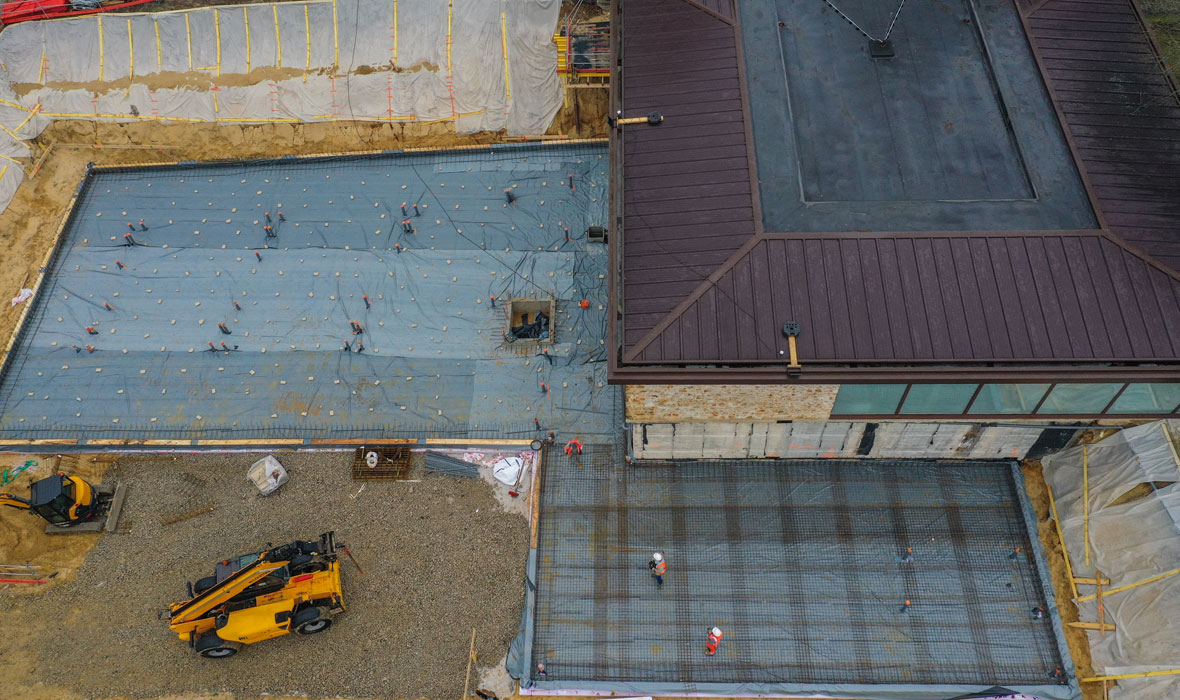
top-left (610, 0), bottom-right (1180, 382)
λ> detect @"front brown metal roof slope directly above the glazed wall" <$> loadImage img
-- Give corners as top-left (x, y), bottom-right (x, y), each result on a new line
top-left (634, 233), bottom-right (1180, 364)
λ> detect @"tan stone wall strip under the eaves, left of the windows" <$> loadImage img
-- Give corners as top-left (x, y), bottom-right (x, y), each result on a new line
top-left (627, 384), bottom-right (840, 423)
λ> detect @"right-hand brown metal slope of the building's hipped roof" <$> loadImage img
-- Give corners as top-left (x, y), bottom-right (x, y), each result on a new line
top-left (1025, 0), bottom-right (1180, 272)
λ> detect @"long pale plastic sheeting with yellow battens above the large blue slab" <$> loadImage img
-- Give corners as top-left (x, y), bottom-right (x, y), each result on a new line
top-left (0, 0), bottom-right (562, 207)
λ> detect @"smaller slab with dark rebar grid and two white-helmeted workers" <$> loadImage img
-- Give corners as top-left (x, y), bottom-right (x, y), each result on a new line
top-left (532, 455), bottom-right (1061, 692)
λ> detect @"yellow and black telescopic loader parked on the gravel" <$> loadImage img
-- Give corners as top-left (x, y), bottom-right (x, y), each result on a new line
top-left (169, 532), bottom-right (345, 659)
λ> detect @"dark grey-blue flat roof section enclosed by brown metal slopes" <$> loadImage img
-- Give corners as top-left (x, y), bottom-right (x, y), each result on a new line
top-left (740, 0), bottom-right (1097, 231)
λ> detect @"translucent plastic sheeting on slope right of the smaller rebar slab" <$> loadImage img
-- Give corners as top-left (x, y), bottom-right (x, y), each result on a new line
top-left (1043, 420), bottom-right (1180, 700)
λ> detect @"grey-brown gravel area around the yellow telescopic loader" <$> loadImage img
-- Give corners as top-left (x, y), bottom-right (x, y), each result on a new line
top-left (2, 453), bottom-right (529, 698)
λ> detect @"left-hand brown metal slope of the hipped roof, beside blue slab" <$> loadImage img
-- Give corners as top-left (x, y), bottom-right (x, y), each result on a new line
top-left (621, 0), bottom-right (755, 345)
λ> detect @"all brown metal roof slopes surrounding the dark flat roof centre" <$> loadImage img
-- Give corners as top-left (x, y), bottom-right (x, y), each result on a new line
top-left (611, 0), bottom-right (1180, 382)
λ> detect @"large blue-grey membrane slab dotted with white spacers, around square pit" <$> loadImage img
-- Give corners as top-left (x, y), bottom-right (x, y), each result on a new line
top-left (0, 144), bottom-right (618, 439)
